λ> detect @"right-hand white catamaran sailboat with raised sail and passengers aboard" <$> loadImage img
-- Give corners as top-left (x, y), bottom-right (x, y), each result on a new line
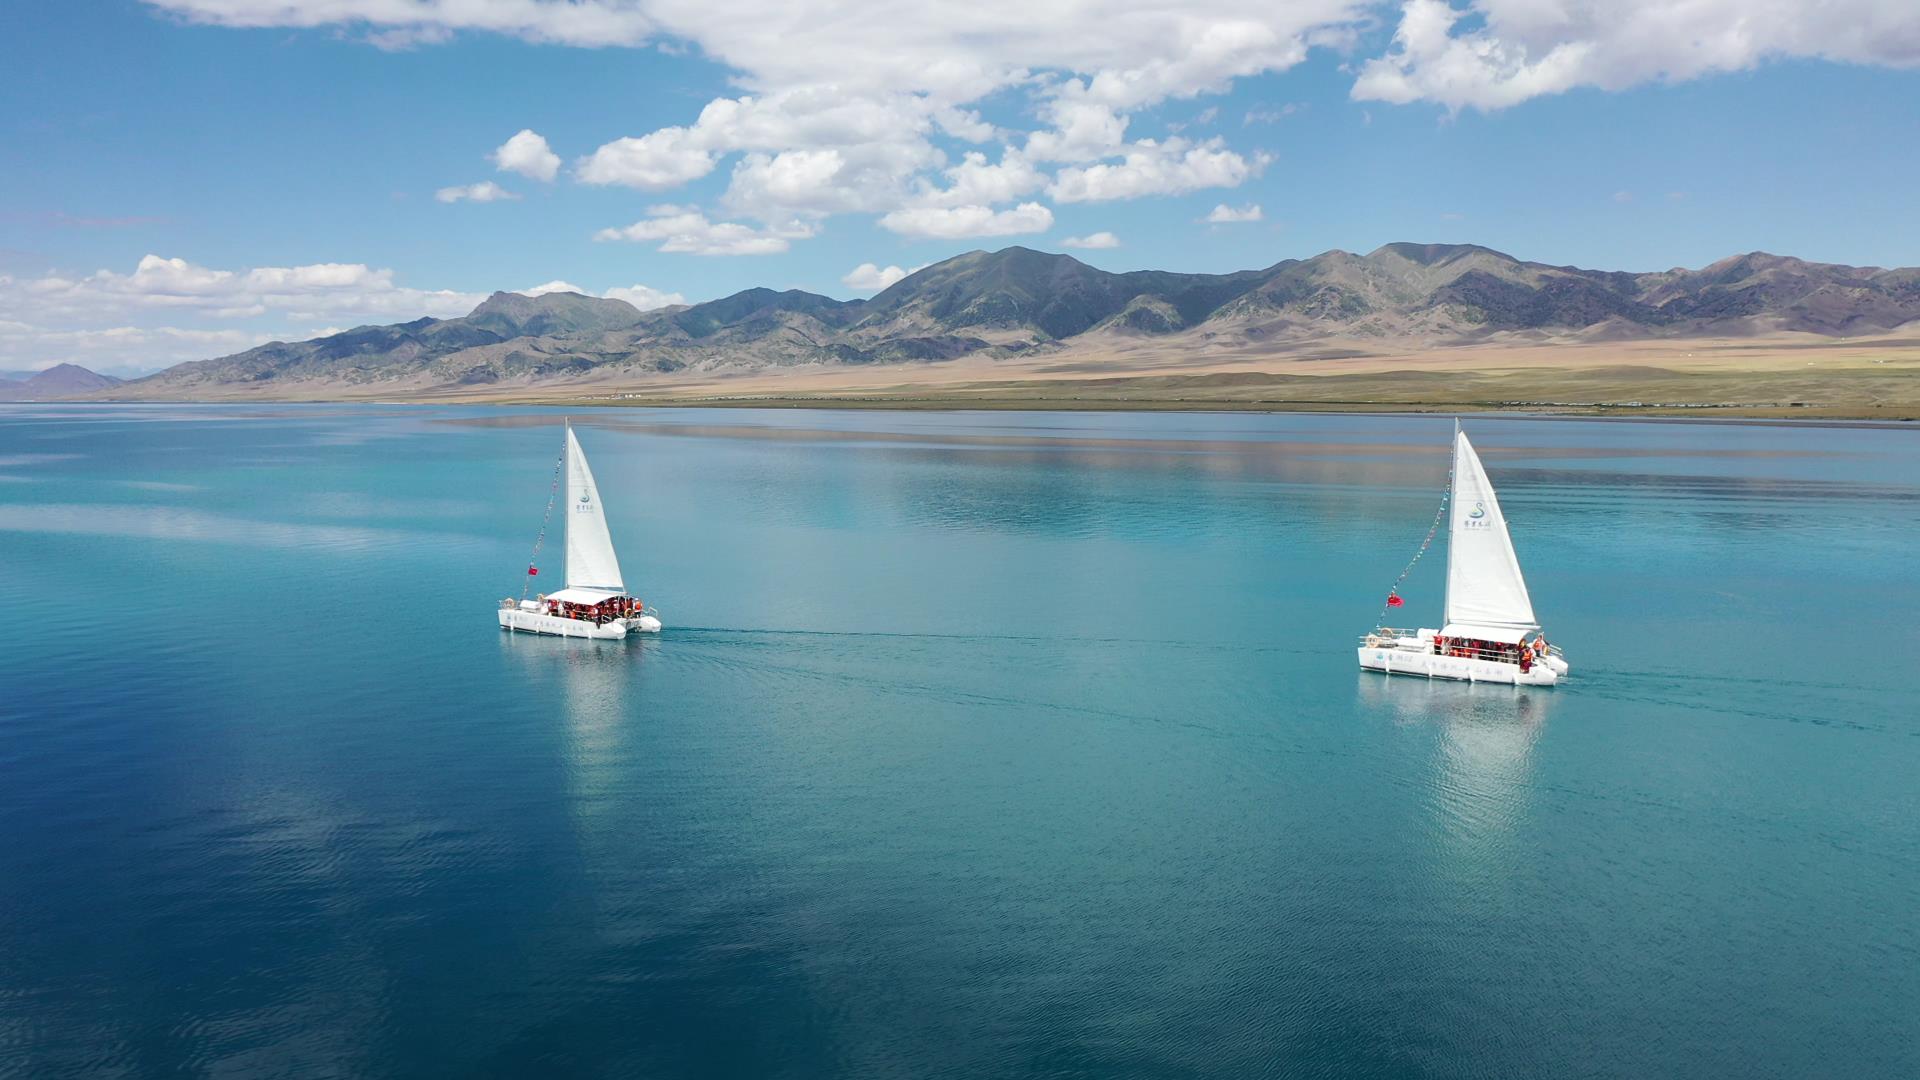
top-left (1359, 421), bottom-right (1567, 686)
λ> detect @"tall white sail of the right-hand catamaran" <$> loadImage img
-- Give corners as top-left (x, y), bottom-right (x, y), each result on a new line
top-left (1446, 432), bottom-right (1538, 630)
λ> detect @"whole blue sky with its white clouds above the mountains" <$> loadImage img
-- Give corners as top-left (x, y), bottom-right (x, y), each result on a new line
top-left (0, 0), bottom-right (1920, 373)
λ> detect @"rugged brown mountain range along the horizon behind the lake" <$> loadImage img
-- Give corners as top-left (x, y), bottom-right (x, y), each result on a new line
top-left (74, 244), bottom-right (1920, 398)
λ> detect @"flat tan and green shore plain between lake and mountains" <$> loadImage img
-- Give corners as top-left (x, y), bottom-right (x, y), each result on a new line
top-left (73, 336), bottom-right (1920, 423)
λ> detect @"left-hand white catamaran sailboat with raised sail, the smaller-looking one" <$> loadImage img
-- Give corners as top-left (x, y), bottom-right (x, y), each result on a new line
top-left (499, 425), bottom-right (660, 640)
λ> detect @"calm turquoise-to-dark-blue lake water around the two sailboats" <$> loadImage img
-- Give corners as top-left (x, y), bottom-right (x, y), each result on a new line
top-left (0, 405), bottom-right (1920, 1078)
